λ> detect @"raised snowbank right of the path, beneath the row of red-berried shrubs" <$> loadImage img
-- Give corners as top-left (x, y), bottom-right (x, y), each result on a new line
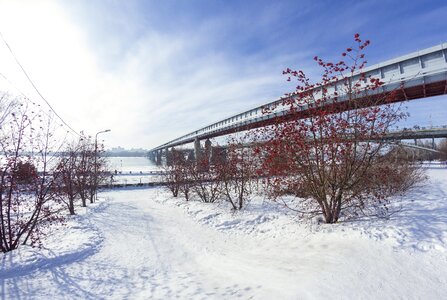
top-left (155, 169), bottom-right (447, 252)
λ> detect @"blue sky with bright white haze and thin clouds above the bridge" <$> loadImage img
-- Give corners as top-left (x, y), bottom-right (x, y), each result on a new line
top-left (0, 0), bottom-right (447, 148)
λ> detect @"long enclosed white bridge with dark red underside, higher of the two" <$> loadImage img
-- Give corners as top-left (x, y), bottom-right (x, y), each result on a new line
top-left (150, 43), bottom-right (447, 156)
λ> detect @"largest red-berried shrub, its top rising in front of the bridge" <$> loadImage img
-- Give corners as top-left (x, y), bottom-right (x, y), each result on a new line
top-left (258, 34), bottom-right (424, 223)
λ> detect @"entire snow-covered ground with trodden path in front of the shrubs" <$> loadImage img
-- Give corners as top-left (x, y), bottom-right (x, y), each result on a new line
top-left (0, 169), bottom-right (447, 299)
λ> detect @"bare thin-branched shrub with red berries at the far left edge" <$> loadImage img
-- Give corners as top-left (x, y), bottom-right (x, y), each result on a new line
top-left (0, 94), bottom-right (62, 252)
